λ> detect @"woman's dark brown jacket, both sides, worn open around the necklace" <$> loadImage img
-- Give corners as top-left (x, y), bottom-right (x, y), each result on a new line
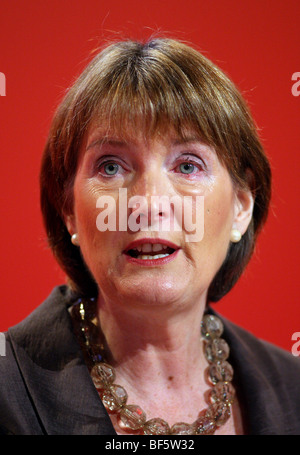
top-left (0, 286), bottom-right (300, 435)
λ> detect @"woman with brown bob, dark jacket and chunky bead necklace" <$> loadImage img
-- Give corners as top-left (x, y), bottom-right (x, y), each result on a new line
top-left (0, 39), bottom-right (300, 435)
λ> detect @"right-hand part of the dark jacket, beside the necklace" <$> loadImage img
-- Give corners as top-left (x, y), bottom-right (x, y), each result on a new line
top-left (211, 315), bottom-right (300, 435)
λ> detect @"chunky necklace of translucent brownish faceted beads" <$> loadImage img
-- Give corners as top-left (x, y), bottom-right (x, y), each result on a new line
top-left (71, 298), bottom-right (235, 435)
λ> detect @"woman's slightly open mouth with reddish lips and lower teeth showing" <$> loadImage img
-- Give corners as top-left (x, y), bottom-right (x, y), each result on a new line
top-left (124, 239), bottom-right (180, 265)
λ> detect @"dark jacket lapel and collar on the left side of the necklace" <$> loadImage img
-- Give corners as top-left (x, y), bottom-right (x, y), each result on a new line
top-left (9, 286), bottom-right (116, 435)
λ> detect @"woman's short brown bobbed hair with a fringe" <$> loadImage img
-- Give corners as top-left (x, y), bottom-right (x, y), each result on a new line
top-left (40, 38), bottom-right (271, 301)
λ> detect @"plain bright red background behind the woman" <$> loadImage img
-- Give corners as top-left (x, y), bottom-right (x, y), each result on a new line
top-left (0, 0), bottom-right (300, 350)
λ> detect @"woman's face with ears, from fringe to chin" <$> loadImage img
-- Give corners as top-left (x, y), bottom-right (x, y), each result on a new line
top-left (66, 127), bottom-right (252, 306)
